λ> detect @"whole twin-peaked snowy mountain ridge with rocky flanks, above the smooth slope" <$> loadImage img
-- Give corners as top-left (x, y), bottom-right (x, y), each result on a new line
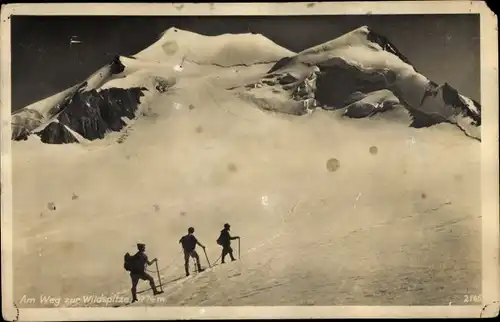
top-left (12, 26), bottom-right (481, 143)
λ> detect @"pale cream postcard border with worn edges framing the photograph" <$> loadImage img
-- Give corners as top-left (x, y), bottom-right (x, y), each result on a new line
top-left (0, 1), bottom-right (500, 321)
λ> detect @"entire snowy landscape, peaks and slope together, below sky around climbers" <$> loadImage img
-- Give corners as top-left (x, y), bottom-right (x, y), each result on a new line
top-left (12, 27), bottom-right (481, 307)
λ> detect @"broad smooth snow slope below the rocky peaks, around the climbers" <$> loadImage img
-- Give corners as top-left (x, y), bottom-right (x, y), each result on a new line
top-left (13, 82), bottom-right (481, 307)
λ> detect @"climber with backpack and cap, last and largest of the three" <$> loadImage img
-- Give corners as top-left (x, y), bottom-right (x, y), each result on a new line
top-left (124, 243), bottom-right (161, 303)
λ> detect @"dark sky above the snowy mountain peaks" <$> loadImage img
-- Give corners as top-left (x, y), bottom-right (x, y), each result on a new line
top-left (11, 14), bottom-right (481, 111)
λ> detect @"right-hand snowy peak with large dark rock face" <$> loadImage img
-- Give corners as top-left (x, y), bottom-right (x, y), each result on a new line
top-left (236, 26), bottom-right (481, 139)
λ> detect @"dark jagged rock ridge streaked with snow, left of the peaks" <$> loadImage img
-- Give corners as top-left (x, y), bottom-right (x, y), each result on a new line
top-left (12, 56), bottom-right (147, 144)
